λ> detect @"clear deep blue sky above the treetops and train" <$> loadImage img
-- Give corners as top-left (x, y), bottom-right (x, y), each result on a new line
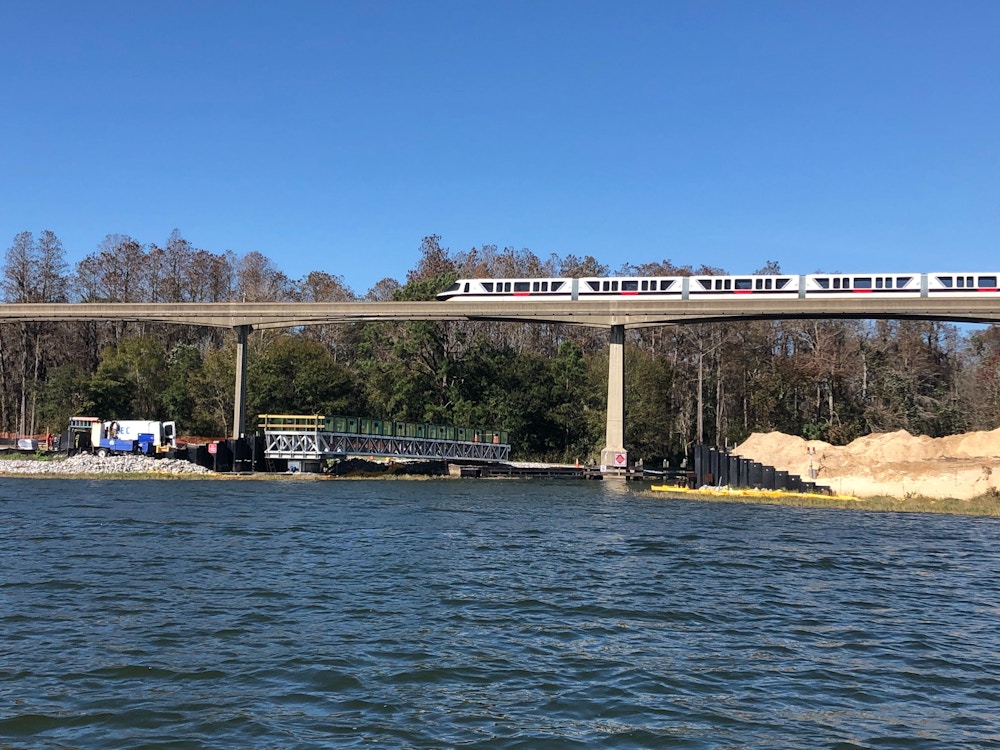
top-left (0, 0), bottom-right (1000, 293)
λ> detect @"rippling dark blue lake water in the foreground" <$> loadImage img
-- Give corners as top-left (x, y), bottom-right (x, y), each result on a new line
top-left (0, 479), bottom-right (1000, 750)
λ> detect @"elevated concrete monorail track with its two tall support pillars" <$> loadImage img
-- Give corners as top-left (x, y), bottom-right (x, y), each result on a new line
top-left (0, 294), bottom-right (1000, 471)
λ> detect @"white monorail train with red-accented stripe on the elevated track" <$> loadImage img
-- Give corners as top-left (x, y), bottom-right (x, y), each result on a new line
top-left (437, 272), bottom-right (1000, 300)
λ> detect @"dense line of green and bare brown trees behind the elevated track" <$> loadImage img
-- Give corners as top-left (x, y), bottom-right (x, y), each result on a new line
top-left (0, 230), bottom-right (1000, 463)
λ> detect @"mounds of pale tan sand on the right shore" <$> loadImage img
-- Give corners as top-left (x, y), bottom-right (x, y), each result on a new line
top-left (733, 429), bottom-right (1000, 500)
